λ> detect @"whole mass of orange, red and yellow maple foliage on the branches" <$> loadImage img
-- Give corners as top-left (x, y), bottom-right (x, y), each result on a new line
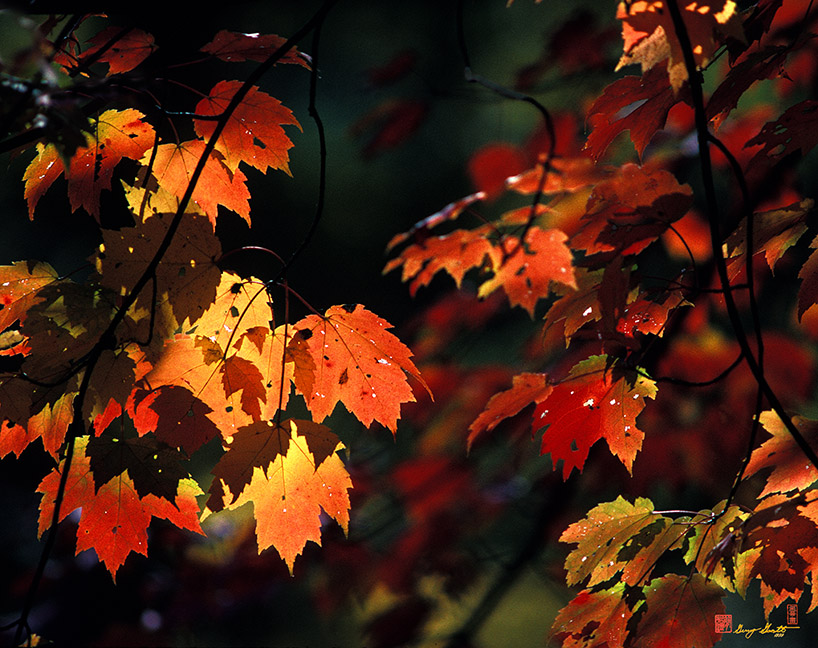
top-left (0, 0), bottom-right (818, 648)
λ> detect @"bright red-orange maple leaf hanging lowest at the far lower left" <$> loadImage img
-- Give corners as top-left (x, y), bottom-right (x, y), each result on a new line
top-left (37, 436), bottom-right (202, 580)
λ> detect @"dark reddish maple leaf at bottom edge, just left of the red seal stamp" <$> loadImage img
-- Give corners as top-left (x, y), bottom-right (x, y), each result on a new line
top-left (633, 574), bottom-right (725, 648)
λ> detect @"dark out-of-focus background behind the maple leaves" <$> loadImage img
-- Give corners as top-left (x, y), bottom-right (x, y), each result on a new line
top-left (0, 0), bottom-right (815, 648)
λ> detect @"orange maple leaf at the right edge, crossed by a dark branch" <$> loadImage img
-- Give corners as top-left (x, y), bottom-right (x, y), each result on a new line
top-left (746, 411), bottom-right (818, 498)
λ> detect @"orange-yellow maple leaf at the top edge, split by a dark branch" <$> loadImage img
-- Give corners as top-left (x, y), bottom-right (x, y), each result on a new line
top-left (616, 0), bottom-right (744, 92)
